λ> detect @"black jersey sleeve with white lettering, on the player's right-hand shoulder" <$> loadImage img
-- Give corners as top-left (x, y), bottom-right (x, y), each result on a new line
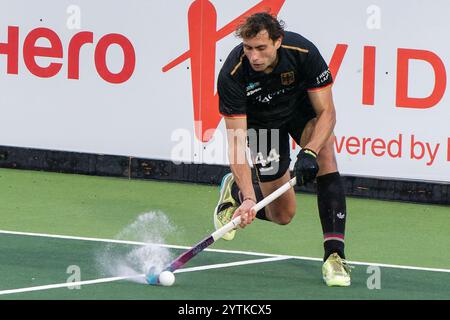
top-left (304, 45), bottom-right (333, 91)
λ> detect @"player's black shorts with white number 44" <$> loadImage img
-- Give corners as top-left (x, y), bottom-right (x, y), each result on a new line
top-left (247, 110), bottom-right (316, 182)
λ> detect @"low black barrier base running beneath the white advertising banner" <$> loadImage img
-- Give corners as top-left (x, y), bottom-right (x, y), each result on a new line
top-left (0, 146), bottom-right (450, 205)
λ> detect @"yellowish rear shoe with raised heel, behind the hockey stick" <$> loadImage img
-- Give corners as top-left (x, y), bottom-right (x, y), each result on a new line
top-left (214, 173), bottom-right (239, 240)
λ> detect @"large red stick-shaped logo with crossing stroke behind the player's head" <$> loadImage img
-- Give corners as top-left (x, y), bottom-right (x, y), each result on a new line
top-left (162, 0), bottom-right (285, 142)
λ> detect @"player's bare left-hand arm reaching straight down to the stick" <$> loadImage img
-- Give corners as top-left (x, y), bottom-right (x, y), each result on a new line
top-left (225, 117), bottom-right (256, 201)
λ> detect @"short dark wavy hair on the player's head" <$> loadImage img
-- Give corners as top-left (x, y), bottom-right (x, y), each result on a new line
top-left (235, 12), bottom-right (284, 41)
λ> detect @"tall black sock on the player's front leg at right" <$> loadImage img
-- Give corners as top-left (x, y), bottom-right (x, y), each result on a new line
top-left (317, 172), bottom-right (347, 261)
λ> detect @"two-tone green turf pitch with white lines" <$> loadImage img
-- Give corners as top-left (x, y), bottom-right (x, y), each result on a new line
top-left (0, 169), bottom-right (450, 300)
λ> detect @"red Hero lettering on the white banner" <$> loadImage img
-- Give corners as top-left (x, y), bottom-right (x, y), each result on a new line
top-left (0, 26), bottom-right (136, 84)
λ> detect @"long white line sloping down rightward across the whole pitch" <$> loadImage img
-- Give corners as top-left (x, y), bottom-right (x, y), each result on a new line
top-left (0, 230), bottom-right (450, 273)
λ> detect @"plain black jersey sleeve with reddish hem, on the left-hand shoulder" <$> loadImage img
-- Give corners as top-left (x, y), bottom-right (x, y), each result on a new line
top-left (217, 72), bottom-right (247, 118)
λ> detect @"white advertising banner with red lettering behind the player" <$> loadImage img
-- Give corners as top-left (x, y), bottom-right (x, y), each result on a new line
top-left (0, 0), bottom-right (450, 183)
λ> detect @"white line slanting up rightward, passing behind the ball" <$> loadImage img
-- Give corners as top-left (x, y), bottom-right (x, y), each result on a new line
top-left (0, 257), bottom-right (290, 295)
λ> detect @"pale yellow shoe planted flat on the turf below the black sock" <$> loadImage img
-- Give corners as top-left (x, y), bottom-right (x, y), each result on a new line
top-left (322, 253), bottom-right (352, 287)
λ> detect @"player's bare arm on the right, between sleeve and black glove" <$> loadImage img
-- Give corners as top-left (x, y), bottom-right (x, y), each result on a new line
top-left (305, 86), bottom-right (336, 154)
